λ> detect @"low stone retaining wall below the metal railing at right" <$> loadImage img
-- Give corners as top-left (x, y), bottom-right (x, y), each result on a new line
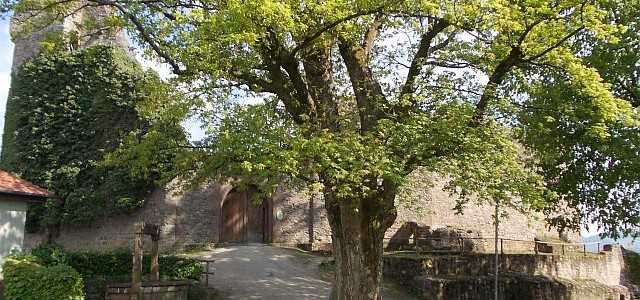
top-left (384, 246), bottom-right (630, 300)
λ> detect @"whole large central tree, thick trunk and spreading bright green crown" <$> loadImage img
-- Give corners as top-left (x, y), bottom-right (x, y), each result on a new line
top-left (5, 0), bottom-right (638, 299)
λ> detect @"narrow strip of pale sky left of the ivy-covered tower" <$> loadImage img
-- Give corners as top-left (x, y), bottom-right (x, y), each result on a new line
top-left (0, 20), bottom-right (13, 148)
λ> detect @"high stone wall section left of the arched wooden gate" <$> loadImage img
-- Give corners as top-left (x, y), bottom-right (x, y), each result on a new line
top-left (25, 184), bottom-right (229, 252)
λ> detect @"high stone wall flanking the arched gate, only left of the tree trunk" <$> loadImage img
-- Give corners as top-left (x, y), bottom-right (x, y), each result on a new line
top-left (25, 184), bottom-right (331, 252)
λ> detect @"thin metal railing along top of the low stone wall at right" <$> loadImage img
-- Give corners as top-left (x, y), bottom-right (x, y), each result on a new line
top-left (384, 237), bottom-right (607, 256)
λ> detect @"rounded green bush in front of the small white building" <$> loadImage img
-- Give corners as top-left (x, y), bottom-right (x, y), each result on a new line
top-left (3, 258), bottom-right (84, 300)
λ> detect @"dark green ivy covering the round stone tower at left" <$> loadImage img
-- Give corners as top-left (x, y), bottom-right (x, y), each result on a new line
top-left (0, 45), bottom-right (162, 231)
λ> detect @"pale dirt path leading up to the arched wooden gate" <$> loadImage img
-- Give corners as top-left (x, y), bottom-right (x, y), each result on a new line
top-left (194, 245), bottom-right (416, 300)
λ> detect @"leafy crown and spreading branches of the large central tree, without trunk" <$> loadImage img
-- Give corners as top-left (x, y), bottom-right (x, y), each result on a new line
top-left (66, 1), bottom-right (637, 236)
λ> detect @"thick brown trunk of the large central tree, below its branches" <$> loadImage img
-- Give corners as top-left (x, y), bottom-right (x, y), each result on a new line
top-left (325, 184), bottom-right (396, 300)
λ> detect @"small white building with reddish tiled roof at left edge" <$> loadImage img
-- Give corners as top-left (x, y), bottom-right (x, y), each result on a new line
top-left (0, 170), bottom-right (53, 279)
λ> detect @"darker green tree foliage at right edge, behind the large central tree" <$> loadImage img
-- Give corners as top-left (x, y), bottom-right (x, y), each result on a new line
top-left (519, 0), bottom-right (640, 238)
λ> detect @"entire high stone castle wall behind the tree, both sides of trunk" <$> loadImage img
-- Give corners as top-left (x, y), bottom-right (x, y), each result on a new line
top-left (25, 173), bottom-right (576, 252)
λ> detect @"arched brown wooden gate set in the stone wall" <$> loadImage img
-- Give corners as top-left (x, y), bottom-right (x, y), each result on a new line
top-left (220, 189), bottom-right (273, 243)
